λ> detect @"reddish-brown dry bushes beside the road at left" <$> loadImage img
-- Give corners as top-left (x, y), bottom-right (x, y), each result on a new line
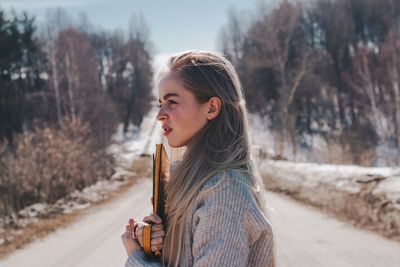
top-left (0, 119), bottom-right (113, 216)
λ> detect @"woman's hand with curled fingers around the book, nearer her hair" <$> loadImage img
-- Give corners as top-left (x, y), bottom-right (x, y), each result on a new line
top-left (135, 213), bottom-right (165, 252)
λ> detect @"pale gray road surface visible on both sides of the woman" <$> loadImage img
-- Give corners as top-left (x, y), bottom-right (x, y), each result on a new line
top-left (0, 179), bottom-right (400, 267)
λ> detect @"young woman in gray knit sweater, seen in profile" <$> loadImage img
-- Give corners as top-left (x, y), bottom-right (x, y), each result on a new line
top-left (122, 51), bottom-right (275, 267)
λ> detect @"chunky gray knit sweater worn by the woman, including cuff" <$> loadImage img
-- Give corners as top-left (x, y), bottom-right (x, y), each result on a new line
top-left (125, 170), bottom-right (274, 267)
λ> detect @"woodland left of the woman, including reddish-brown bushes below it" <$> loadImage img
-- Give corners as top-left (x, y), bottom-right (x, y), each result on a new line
top-left (0, 9), bottom-right (153, 218)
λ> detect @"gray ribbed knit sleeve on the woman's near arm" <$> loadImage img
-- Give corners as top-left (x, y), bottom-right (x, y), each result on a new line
top-left (192, 179), bottom-right (250, 266)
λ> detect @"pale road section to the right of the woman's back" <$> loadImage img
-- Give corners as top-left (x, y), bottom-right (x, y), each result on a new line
top-left (268, 193), bottom-right (400, 267)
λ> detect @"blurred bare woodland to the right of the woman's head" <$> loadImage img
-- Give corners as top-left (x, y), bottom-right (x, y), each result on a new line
top-left (219, 0), bottom-right (400, 165)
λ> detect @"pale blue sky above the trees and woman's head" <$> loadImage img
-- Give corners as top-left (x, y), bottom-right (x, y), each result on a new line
top-left (0, 0), bottom-right (262, 57)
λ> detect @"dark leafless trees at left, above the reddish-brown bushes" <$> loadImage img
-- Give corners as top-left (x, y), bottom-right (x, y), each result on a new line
top-left (0, 9), bottom-right (153, 144)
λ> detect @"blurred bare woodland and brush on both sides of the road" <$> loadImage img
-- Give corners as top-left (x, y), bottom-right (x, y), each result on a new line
top-left (0, 0), bottom-right (400, 218)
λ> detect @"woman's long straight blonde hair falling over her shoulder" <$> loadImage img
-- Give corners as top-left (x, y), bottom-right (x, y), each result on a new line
top-left (164, 51), bottom-right (266, 266)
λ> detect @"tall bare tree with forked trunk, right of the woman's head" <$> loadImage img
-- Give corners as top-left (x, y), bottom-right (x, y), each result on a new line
top-left (247, 1), bottom-right (312, 155)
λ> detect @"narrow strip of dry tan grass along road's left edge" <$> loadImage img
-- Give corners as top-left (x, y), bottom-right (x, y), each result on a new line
top-left (0, 157), bottom-right (151, 259)
